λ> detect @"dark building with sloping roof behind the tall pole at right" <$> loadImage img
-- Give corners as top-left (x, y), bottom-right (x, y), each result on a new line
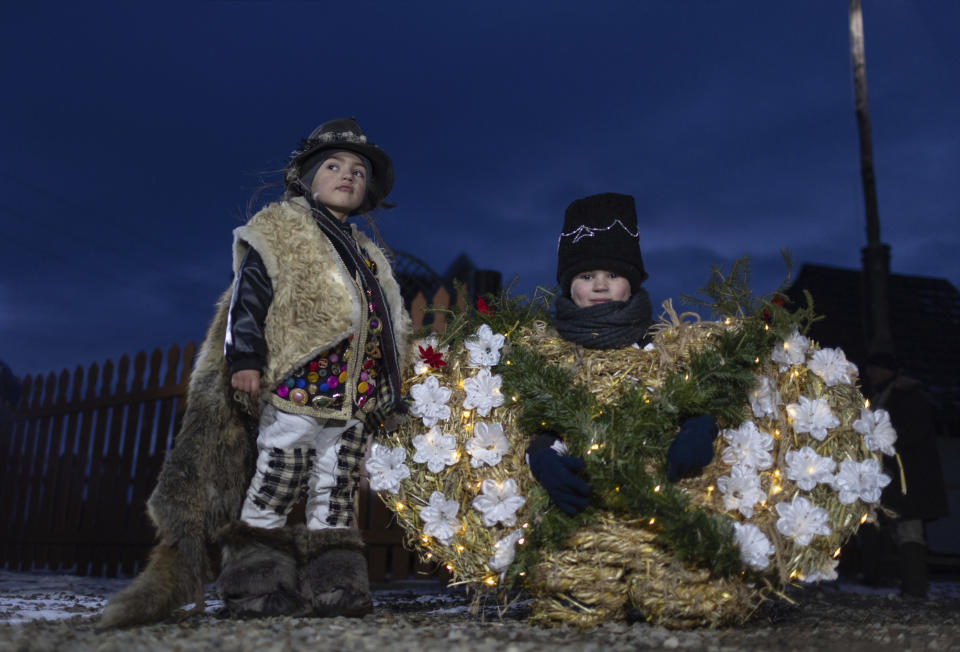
top-left (787, 265), bottom-right (960, 430)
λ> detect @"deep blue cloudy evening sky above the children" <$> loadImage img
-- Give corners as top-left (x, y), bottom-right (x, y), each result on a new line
top-left (0, 0), bottom-right (960, 375)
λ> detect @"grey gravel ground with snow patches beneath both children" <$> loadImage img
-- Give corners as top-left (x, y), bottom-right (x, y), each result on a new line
top-left (0, 572), bottom-right (960, 652)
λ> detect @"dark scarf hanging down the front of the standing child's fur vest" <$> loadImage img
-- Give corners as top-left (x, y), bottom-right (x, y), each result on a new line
top-left (310, 201), bottom-right (401, 407)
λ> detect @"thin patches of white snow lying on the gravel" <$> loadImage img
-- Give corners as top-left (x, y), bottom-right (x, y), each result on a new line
top-left (0, 570), bottom-right (960, 624)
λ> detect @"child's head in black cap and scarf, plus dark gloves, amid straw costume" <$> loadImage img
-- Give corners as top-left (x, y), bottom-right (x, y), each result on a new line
top-left (527, 193), bottom-right (717, 515)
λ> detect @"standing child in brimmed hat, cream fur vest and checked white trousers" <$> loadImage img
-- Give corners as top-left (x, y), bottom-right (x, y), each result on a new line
top-left (101, 119), bottom-right (410, 627)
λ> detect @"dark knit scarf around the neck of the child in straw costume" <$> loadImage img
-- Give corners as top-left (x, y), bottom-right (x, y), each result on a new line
top-left (553, 288), bottom-right (653, 349)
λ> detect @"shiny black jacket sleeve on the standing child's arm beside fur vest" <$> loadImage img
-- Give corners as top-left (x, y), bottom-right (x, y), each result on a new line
top-left (223, 247), bottom-right (273, 374)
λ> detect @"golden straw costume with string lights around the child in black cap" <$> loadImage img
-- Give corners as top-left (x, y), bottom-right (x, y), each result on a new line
top-left (370, 304), bottom-right (892, 628)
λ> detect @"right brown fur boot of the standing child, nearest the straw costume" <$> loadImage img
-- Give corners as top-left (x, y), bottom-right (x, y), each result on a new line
top-left (297, 527), bottom-right (373, 618)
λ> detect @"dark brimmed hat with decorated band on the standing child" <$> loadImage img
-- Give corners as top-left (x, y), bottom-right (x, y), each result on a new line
top-left (283, 118), bottom-right (393, 212)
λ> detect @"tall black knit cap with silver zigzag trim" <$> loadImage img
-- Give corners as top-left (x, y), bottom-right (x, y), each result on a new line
top-left (557, 192), bottom-right (649, 296)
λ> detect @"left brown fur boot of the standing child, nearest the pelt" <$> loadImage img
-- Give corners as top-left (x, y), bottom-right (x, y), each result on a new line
top-left (217, 521), bottom-right (310, 618)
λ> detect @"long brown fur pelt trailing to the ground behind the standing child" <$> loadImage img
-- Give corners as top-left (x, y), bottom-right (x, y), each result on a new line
top-left (99, 290), bottom-right (256, 628)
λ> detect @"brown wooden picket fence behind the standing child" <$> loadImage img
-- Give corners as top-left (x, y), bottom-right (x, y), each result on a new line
top-left (0, 288), bottom-right (462, 582)
